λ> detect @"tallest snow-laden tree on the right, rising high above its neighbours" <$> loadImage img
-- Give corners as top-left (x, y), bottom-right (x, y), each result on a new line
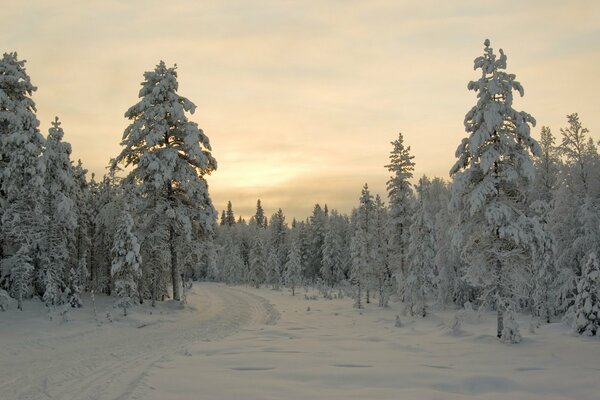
top-left (450, 40), bottom-right (540, 337)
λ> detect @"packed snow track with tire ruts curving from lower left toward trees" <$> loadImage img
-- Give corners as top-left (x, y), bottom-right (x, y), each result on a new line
top-left (0, 283), bottom-right (279, 400)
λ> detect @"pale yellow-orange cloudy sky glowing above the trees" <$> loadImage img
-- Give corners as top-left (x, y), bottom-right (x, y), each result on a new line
top-left (0, 0), bottom-right (600, 221)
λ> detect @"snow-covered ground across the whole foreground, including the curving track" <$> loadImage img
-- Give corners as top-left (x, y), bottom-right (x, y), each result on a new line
top-left (0, 284), bottom-right (600, 400)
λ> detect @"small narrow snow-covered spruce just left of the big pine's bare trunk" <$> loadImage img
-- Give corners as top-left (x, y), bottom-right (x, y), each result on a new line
top-left (111, 210), bottom-right (142, 315)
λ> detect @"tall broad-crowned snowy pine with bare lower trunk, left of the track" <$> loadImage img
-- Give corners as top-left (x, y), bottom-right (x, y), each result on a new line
top-left (113, 61), bottom-right (217, 300)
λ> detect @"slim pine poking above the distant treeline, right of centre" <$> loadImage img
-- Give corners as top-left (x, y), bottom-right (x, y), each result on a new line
top-left (385, 133), bottom-right (415, 296)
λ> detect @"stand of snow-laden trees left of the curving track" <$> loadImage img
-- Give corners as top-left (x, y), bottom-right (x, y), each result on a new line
top-left (0, 53), bottom-right (216, 313)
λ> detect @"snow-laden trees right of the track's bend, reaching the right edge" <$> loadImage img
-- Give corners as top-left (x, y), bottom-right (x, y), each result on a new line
top-left (207, 41), bottom-right (600, 342)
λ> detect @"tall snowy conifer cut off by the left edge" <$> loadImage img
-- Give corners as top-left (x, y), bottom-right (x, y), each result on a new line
top-left (0, 53), bottom-right (44, 308)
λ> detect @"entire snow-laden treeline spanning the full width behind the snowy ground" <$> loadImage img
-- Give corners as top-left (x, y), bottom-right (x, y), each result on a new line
top-left (0, 41), bottom-right (600, 342)
